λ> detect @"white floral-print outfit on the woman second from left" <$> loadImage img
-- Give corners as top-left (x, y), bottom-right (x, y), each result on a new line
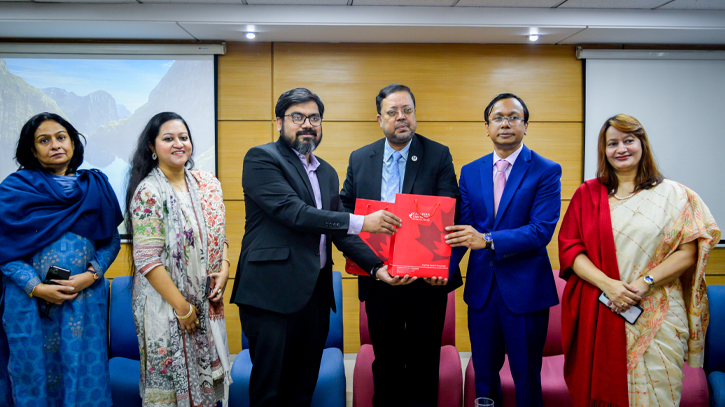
top-left (131, 168), bottom-right (231, 407)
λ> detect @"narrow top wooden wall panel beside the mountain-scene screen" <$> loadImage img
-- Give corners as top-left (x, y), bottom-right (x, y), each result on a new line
top-left (217, 43), bottom-right (277, 121)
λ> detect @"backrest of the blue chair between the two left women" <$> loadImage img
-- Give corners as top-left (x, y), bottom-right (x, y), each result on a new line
top-left (108, 276), bottom-right (140, 360)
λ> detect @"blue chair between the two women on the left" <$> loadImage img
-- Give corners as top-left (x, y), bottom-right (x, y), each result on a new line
top-left (108, 276), bottom-right (142, 407)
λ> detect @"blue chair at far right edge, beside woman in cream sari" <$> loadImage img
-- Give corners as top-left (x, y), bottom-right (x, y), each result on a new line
top-left (705, 285), bottom-right (725, 407)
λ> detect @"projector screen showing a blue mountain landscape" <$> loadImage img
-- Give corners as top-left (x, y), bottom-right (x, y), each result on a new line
top-left (0, 54), bottom-right (216, 222)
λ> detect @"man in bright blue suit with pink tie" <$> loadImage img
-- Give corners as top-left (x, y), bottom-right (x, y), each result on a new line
top-left (446, 93), bottom-right (561, 407)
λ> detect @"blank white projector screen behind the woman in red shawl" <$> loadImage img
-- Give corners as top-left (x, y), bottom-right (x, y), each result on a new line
top-left (584, 59), bottom-right (725, 243)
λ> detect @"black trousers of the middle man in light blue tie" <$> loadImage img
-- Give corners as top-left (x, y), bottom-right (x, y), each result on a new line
top-left (365, 280), bottom-right (448, 407)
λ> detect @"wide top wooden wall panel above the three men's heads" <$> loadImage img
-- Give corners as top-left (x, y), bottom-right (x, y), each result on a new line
top-left (272, 43), bottom-right (583, 122)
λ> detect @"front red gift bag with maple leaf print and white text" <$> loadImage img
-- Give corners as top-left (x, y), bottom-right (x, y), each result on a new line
top-left (388, 194), bottom-right (456, 278)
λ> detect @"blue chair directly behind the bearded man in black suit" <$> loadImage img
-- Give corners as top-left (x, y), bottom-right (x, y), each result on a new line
top-left (229, 271), bottom-right (345, 407)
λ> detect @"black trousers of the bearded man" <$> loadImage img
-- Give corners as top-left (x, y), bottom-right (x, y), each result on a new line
top-left (239, 273), bottom-right (332, 407)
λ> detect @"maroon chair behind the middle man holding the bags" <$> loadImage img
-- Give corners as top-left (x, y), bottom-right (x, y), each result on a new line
top-left (352, 292), bottom-right (463, 407)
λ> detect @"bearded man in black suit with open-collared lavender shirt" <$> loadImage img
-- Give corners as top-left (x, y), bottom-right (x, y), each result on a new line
top-left (232, 88), bottom-right (400, 407)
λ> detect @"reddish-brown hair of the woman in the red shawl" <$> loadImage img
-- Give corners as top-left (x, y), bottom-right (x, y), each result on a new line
top-left (597, 114), bottom-right (665, 194)
